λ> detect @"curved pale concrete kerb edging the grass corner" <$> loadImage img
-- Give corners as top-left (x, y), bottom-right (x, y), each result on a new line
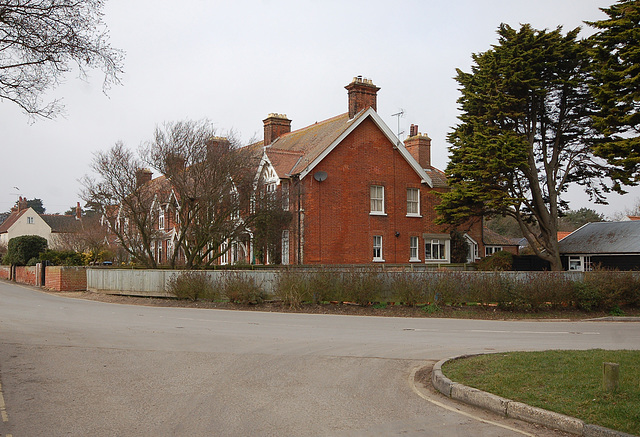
top-left (431, 354), bottom-right (634, 437)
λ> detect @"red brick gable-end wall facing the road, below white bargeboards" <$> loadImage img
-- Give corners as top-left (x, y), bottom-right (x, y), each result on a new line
top-left (290, 119), bottom-right (470, 264)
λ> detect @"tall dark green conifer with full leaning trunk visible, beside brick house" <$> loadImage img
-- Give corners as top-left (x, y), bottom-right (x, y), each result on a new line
top-left (437, 24), bottom-right (607, 270)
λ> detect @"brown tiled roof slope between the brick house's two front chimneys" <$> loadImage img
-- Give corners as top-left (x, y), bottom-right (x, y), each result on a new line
top-left (266, 113), bottom-right (358, 176)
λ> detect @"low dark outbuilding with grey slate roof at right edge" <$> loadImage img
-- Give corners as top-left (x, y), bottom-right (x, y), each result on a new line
top-left (559, 220), bottom-right (640, 271)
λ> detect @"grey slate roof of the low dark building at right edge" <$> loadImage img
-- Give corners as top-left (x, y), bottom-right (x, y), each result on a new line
top-left (559, 221), bottom-right (640, 255)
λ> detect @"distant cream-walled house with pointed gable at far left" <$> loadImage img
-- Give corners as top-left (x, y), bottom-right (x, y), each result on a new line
top-left (0, 197), bottom-right (81, 247)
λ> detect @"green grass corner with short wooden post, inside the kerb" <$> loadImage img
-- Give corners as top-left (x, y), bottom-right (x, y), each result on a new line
top-left (442, 349), bottom-right (640, 435)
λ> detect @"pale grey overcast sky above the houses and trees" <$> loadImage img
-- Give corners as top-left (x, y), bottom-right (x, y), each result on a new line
top-left (0, 0), bottom-right (640, 216)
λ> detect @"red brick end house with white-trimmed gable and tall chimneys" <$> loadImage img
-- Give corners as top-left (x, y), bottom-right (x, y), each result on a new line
top-left (254, 77), bottom-right (484, 264)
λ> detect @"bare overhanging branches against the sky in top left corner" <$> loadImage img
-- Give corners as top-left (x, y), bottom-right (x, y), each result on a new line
top-left (0, 0), bottom-right (123, 118)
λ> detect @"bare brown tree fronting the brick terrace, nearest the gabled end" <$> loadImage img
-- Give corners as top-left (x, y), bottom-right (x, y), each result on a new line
top-left (142, 120), bottom-right (257, 268)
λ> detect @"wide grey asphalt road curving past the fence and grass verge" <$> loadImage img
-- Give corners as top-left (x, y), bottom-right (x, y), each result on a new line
top-left (0, 281), bottom-right (640, 437)
